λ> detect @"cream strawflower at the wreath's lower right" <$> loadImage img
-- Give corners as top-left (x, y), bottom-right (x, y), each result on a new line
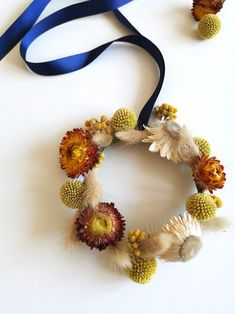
top-left (160, 214), bottom-right (202, 262)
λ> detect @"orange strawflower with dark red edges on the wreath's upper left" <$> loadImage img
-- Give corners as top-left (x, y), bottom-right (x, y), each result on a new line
top-left (60, 129), bottom-right (98, 178)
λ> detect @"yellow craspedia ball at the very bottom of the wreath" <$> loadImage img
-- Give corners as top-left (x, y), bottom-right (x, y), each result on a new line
top-left (126, 256), bottom-right (157, 284)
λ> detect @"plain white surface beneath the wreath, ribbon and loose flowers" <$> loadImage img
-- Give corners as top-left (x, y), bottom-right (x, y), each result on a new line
top-left (0, 0), bottom-right (235, 314)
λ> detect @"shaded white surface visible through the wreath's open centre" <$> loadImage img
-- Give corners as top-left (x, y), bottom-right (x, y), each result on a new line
top-left (100, 145), bottom-right (194, 229)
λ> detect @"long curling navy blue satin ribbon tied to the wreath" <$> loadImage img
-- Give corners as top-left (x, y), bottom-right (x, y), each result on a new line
top-left (0, 0), bottom-right (165, 129)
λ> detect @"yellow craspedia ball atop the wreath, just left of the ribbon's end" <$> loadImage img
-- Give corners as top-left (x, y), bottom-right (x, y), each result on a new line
top-left (111, 108), bottom-right (137, 132)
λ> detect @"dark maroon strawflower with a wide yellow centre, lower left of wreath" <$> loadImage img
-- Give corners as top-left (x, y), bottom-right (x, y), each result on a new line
top-left (76, 203), bottom-right (125, 251)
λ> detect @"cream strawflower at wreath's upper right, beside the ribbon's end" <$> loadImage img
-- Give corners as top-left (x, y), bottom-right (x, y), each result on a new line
top-left (143, 121), bottom-right (199, 163)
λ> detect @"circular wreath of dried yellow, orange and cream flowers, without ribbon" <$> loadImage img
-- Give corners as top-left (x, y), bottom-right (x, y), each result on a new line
top-left (60, 104), bottom-right (226, 284)
